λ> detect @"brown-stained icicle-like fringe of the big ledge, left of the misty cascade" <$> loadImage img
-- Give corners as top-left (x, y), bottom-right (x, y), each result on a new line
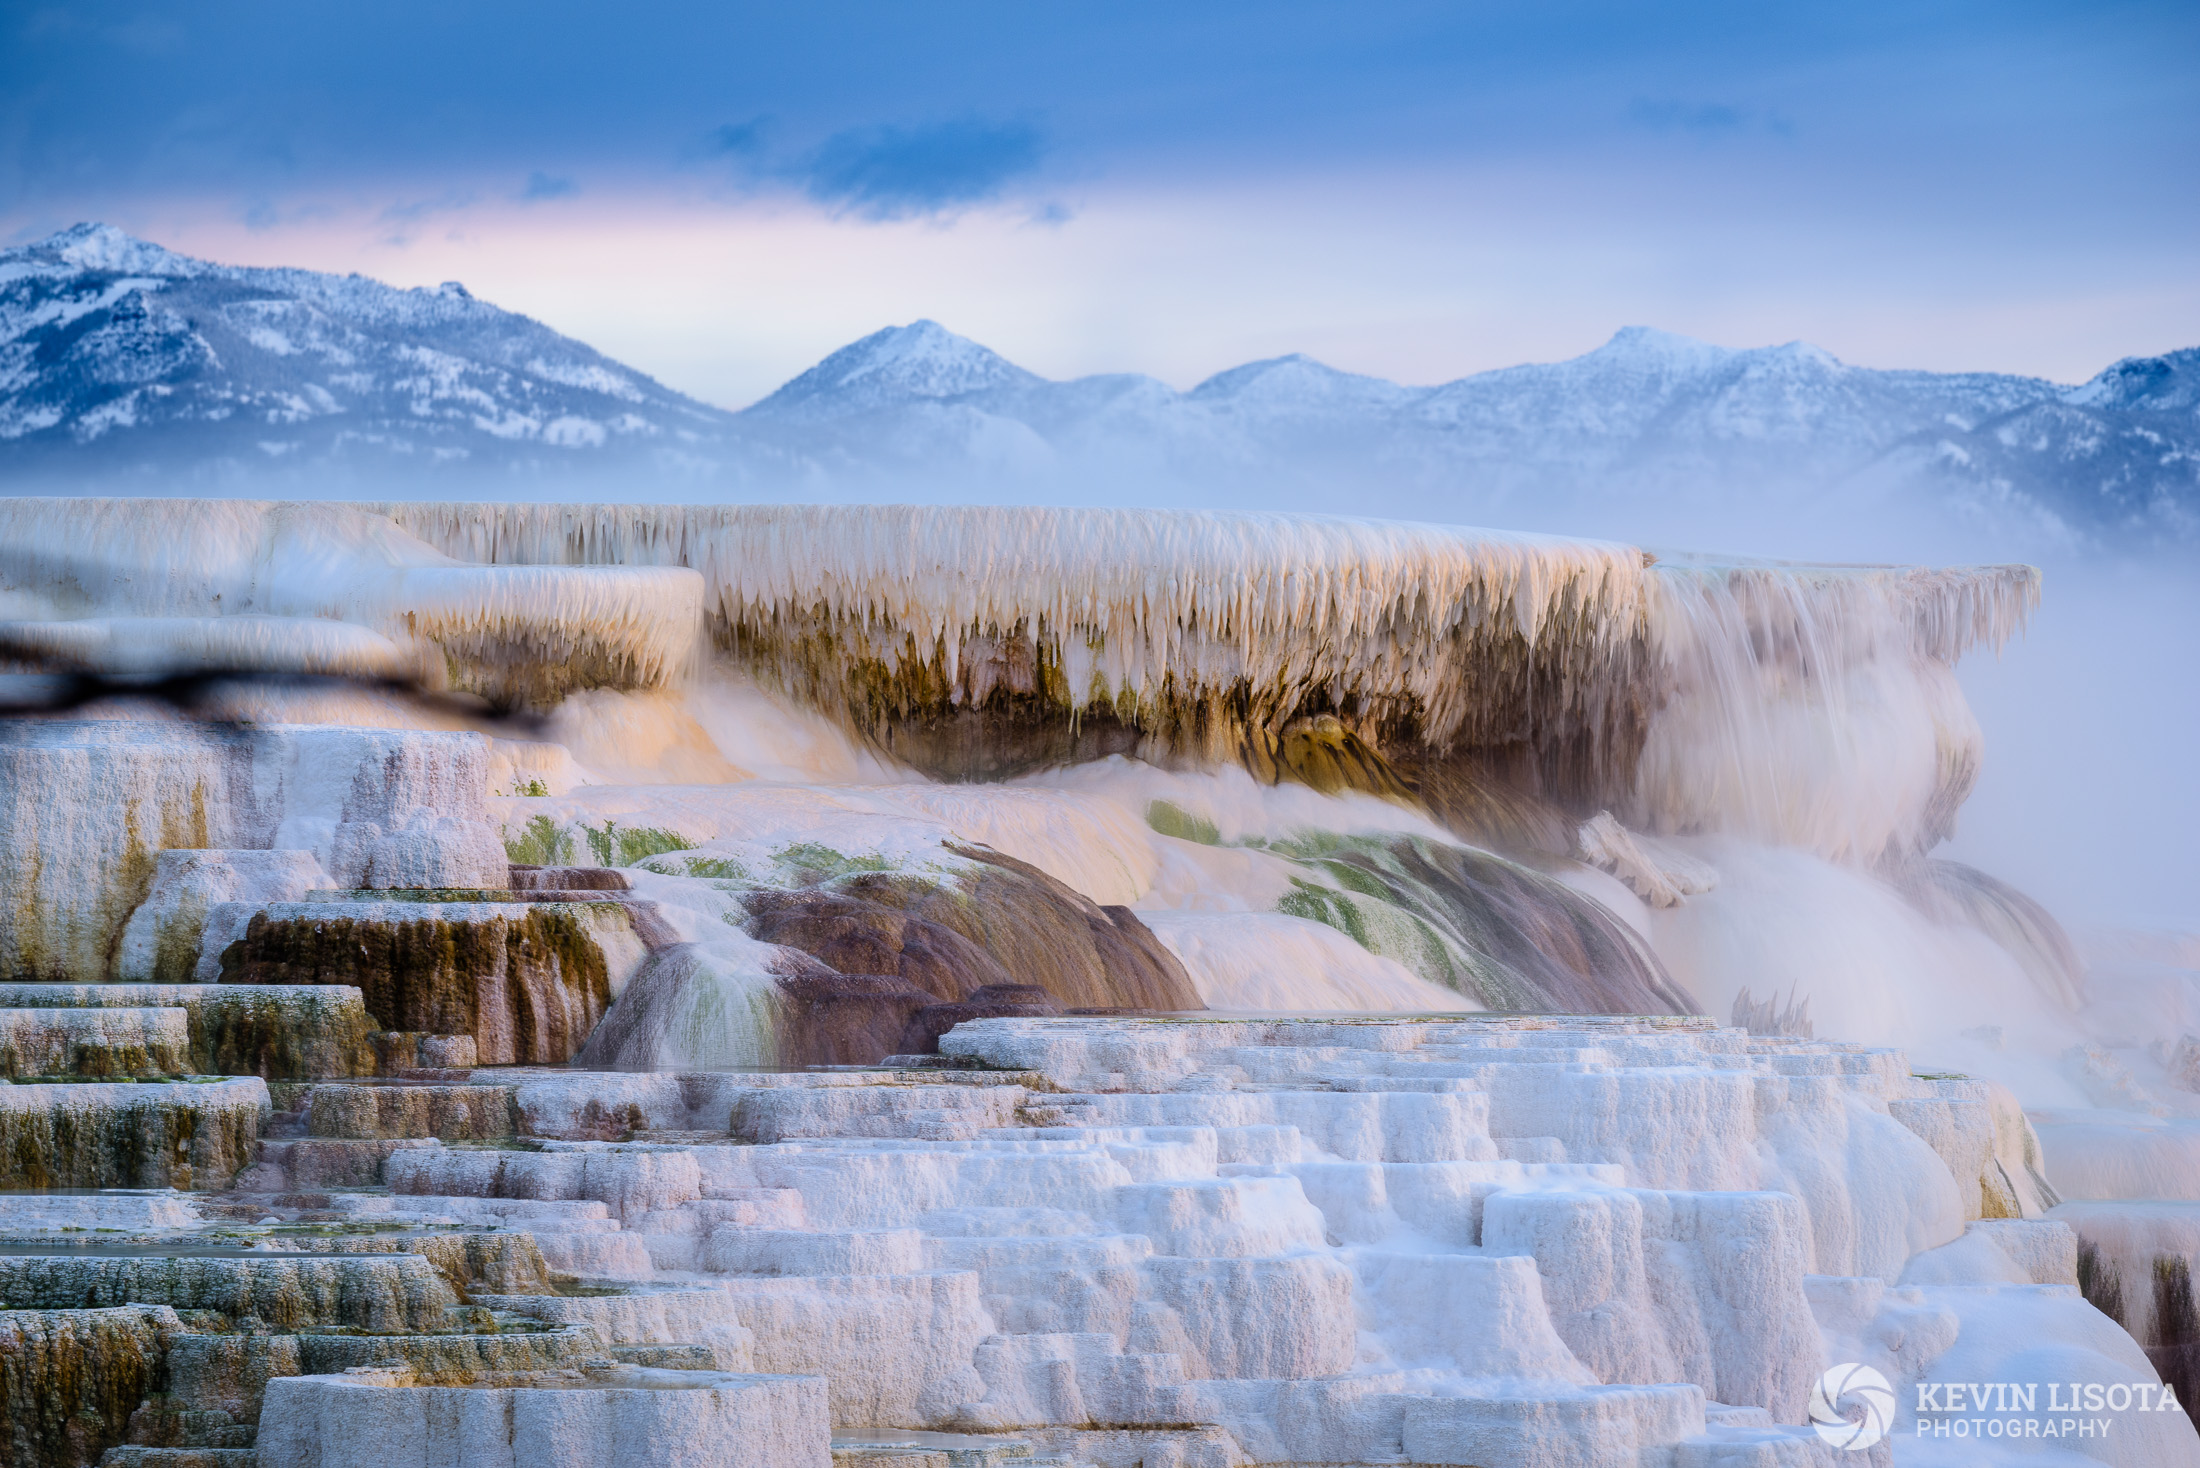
top-left (372, 504), bottom-right (1648, 753)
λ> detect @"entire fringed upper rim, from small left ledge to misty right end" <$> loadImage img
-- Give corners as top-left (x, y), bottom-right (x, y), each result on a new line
top-left (0, 500), bottom-right (2037, 863)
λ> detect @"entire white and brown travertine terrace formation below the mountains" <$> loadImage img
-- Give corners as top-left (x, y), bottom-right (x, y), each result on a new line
top-left (0, 502), bottom-right (2200, 1468)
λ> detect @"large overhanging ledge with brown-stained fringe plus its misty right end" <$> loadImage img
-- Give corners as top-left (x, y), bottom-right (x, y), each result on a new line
top-left (374, 504), bottom-right (2039, 861)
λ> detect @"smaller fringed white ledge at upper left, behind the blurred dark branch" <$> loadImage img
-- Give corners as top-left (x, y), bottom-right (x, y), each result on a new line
top-left (0, 500), bottom-right (702, 702)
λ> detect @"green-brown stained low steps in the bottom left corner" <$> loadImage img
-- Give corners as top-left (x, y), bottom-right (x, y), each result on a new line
top-left (0, 1195), bottom-right (750, 1468)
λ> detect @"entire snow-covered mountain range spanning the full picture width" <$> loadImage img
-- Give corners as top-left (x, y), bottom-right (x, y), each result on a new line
top-left (0, 224), bottom-right (2200, 544)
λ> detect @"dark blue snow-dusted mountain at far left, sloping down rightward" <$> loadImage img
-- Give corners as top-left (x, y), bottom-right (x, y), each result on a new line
top-left (0, 224), bottom-right (761, 482)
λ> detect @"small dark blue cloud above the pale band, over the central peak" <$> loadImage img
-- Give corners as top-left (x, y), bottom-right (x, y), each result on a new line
top-left (788, 119), bottom-right (1043, 220)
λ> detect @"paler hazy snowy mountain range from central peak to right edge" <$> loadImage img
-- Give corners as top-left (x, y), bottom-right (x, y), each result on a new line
top-left (741, 321), bottom-right (2200, 548)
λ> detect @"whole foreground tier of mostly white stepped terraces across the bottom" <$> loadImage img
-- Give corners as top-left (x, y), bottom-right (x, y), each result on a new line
top-left (0, 1017), bottom-right (2191, 1468)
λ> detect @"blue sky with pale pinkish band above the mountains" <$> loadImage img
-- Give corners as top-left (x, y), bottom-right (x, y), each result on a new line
top-left (0, 0), bottom-right (2200, 403)
